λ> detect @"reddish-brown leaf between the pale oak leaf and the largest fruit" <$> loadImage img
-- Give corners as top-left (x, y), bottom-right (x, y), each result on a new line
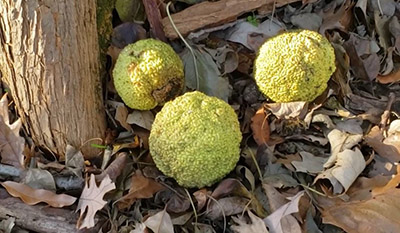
top-left (118, 170), bottom-right (165, 209)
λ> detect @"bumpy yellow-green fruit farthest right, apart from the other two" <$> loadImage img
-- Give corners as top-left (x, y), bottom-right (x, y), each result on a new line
top-left (254, 30), bottom-right (335, 102)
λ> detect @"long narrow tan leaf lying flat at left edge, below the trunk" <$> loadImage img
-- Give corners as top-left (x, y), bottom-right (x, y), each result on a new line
top-left (1, 181), bottom-right (76, 208)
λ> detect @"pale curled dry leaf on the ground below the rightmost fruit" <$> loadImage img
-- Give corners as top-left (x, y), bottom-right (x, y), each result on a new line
top-left (314, 148), bottom-right (366, 194)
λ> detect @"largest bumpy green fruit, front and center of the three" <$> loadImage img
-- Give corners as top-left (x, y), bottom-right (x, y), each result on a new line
top-left (149, 91), bottom-right (242, 188)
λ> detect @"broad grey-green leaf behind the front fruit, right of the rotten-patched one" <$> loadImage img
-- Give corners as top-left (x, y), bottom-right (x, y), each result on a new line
top-left (180, 45), bottom-right (232, 102)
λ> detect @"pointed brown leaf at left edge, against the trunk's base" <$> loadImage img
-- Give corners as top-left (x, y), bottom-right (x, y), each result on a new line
top-left (0, 94), bottom-right (25, 169)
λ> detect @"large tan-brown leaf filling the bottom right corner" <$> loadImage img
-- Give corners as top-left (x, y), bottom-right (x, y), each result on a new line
top-left (318, 168), bottom-right (400, 233)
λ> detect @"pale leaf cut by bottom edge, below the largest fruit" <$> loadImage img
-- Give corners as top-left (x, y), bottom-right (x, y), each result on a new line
top-left (144, 210), bottom-right (174, 233)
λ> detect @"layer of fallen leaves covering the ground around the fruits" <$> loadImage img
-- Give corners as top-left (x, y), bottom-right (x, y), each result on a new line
top-left (0, 0), bottom-right (400, 233)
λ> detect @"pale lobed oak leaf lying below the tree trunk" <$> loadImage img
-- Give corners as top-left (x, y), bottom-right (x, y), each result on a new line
top-left (76, 174), bottom-right (115, 229)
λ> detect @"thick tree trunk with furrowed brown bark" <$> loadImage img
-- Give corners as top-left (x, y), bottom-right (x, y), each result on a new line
top-left (0, 0), bottom-right (106, 158)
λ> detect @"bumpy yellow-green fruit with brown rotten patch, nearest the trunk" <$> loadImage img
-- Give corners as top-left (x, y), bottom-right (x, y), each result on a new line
top-left (113, 39), bottom-right (184, 110)
